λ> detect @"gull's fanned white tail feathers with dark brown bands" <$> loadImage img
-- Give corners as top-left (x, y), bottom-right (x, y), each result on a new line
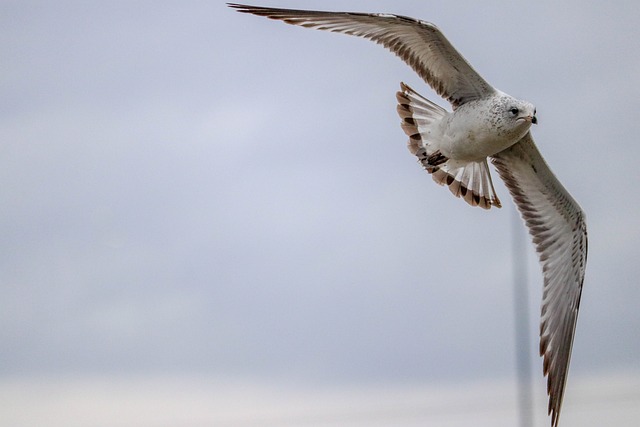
top-left (396, 83), bottom-right (502, 209)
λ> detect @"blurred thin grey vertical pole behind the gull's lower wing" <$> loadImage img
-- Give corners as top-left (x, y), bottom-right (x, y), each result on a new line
top-left (511, 209), bottom-right (533, 427)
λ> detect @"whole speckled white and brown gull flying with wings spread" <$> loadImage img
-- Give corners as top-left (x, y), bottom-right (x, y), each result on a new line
top-left (228, 3), bottom-right (587, 427)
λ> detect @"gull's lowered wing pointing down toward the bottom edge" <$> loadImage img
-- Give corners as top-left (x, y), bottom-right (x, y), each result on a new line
top-left (492, 133), bottom-right (587, 426)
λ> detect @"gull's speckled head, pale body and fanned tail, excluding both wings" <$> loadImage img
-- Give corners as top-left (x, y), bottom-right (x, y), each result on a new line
top-left (397, 84), bottom-right (537, 209)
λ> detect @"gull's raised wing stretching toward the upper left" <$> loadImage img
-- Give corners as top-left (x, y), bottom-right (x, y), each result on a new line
top-left (229, 3), bottom-right (495, 108)
